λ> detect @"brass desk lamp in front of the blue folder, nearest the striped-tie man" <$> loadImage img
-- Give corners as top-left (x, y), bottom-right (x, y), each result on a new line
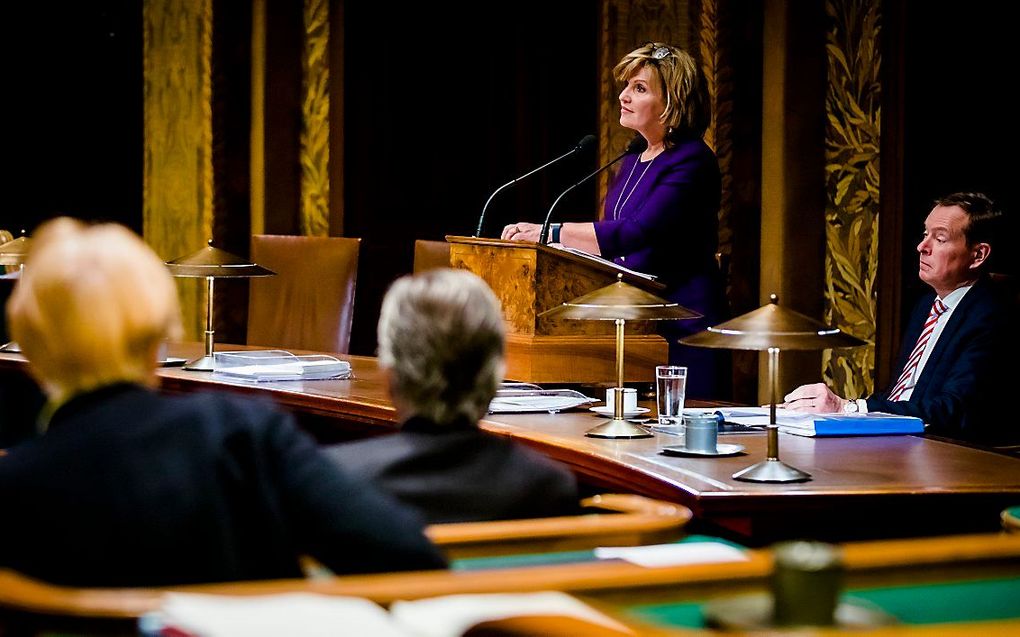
top-left (680, 295), bottom-right (865, 482)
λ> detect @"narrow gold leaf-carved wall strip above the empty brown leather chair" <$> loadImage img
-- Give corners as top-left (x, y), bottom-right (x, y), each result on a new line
top-left (301, 0), bottom-right (329, 236)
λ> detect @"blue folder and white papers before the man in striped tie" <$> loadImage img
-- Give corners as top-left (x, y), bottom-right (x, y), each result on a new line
top-left (716, 407), bottom-right (924, 436)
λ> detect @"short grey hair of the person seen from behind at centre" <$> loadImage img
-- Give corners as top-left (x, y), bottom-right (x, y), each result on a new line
top-left (378, 268), bottom-right (506, 425)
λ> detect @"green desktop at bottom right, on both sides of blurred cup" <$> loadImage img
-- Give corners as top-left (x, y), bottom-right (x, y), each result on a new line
top-left (624, 577), bottom-right (1020, 628)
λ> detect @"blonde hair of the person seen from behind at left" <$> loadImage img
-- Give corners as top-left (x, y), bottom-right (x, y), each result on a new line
top-left (7, 217), bottom-right (181, 403)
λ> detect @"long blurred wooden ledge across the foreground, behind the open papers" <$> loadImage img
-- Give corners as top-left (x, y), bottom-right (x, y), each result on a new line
top-left (0, 534), bottom-right (1020, 628)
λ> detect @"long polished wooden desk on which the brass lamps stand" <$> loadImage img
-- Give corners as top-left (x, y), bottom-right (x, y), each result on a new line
top-left (0, 347), bottom-right (1020, 545)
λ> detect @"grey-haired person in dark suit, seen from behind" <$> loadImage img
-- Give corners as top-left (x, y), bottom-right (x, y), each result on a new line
top-left (327, 268), bottom-right (577, 523)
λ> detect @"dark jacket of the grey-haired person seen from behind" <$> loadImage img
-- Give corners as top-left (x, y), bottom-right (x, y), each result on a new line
top-left (327, 418), bottom-right (578, 524)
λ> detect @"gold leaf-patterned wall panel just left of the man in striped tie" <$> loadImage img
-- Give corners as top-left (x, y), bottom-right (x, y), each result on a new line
top-left (822, 0), bottom-right (881, 397)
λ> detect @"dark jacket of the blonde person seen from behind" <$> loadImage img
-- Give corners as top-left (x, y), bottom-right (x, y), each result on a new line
top-left (0, 384), bottom-right (445, 586)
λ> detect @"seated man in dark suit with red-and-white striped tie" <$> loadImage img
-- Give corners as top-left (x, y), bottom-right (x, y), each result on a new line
top-left (783, 193), bottom-right (1020, 444)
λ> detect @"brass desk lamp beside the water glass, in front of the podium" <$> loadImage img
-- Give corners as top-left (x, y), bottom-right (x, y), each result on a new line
top-left (539, 274), bottom-right (701, 438)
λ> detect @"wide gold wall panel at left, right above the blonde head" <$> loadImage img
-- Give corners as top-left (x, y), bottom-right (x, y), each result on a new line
top-left (142, 0), bottom-right (213, 339)
